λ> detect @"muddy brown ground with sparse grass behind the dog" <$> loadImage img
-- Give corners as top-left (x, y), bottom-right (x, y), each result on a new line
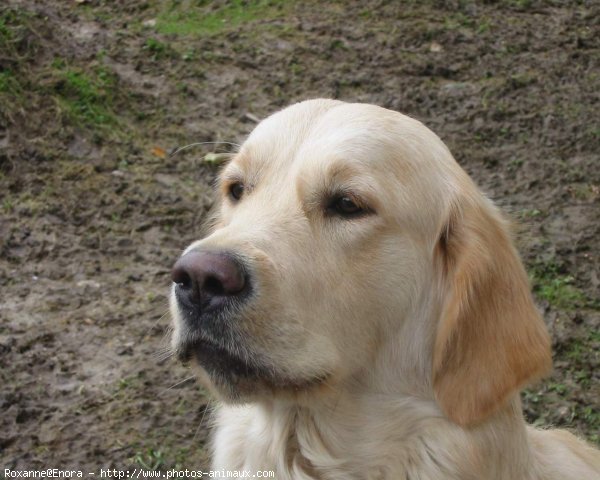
top-left (0, 0), bottom-right (600, 476)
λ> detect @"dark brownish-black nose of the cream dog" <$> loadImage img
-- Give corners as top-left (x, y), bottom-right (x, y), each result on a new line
top-left (171, 250), bottom-right (248, 308)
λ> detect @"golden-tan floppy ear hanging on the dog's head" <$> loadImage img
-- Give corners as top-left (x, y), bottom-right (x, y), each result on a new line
top-left (433, 195), bottom-right (551, 426)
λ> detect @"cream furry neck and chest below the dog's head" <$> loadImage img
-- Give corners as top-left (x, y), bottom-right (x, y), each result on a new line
top-left (213, 362), bottom-right (531, 480)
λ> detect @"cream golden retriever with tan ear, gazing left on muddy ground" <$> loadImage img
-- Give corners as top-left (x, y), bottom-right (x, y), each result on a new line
top-left (171, 100), bottom-right (600, 480)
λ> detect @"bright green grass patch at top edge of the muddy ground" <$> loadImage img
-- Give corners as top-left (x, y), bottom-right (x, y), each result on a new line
top-left (156, 0), bottom-right (289, 37)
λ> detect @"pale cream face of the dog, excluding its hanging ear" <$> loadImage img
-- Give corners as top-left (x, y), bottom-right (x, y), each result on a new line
top-left (171, 100), bottom-right (552, 424)
